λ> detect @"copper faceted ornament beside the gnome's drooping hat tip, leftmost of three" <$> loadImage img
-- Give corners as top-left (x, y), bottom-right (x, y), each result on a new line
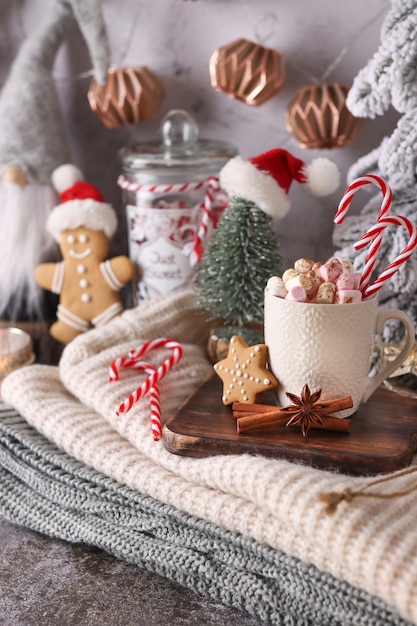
top-left (87, 67), bottom-right (164, 128)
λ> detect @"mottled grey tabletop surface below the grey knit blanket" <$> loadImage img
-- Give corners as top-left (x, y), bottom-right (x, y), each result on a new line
top-left (0, 518), bottom-right (260, 626)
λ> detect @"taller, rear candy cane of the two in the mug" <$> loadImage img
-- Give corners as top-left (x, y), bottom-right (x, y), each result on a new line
top-left (334, 174), bottom-right (392, 294)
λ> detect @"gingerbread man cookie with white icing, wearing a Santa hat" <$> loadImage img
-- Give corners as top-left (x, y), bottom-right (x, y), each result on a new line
top-left (35, 165), bottom-right (135, 343)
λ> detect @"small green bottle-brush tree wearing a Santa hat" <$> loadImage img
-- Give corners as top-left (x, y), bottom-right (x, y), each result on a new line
top-left (197, 149), bottom-right (339, 356)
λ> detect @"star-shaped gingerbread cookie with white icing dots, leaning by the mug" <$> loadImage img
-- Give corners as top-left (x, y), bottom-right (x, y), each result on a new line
top-left (214, 335), bottom-right (278, 404)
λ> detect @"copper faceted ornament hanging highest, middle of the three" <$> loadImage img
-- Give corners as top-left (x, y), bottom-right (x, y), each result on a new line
top-left (209, 39), bottom-right (285, 106)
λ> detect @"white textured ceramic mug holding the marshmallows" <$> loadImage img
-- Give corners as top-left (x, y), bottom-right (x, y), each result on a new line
top-left (265, 289), bottom-right (414, 417)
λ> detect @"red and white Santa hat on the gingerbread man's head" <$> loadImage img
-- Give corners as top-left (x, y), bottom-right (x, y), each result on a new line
top-left (46, 164), bottom-right (117, 242)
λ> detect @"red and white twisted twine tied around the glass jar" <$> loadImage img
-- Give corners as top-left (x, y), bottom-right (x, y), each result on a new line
top-left (117, 175), bottom-right (226, 266)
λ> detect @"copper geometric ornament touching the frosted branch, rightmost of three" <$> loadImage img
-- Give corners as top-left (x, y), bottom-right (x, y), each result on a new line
top-left (285, 83), bottom-right (364, 149)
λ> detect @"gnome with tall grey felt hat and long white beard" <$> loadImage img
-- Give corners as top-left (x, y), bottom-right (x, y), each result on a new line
top-left (0, 0), bottom-right (110, 321)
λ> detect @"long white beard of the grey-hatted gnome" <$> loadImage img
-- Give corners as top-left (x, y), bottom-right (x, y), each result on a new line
top-left (0, 181), bottom-right (57, 320)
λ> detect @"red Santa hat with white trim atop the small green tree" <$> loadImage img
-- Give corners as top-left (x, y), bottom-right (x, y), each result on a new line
top-left (220, 148), bottom-right (340, 219)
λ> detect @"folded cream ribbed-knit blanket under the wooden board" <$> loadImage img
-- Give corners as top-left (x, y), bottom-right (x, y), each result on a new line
top-left (2, 292), bottom-right (417, 623)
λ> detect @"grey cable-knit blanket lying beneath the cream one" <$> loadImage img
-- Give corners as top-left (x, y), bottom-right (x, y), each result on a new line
top-left (0, 405), bottom-right (410, 626)
